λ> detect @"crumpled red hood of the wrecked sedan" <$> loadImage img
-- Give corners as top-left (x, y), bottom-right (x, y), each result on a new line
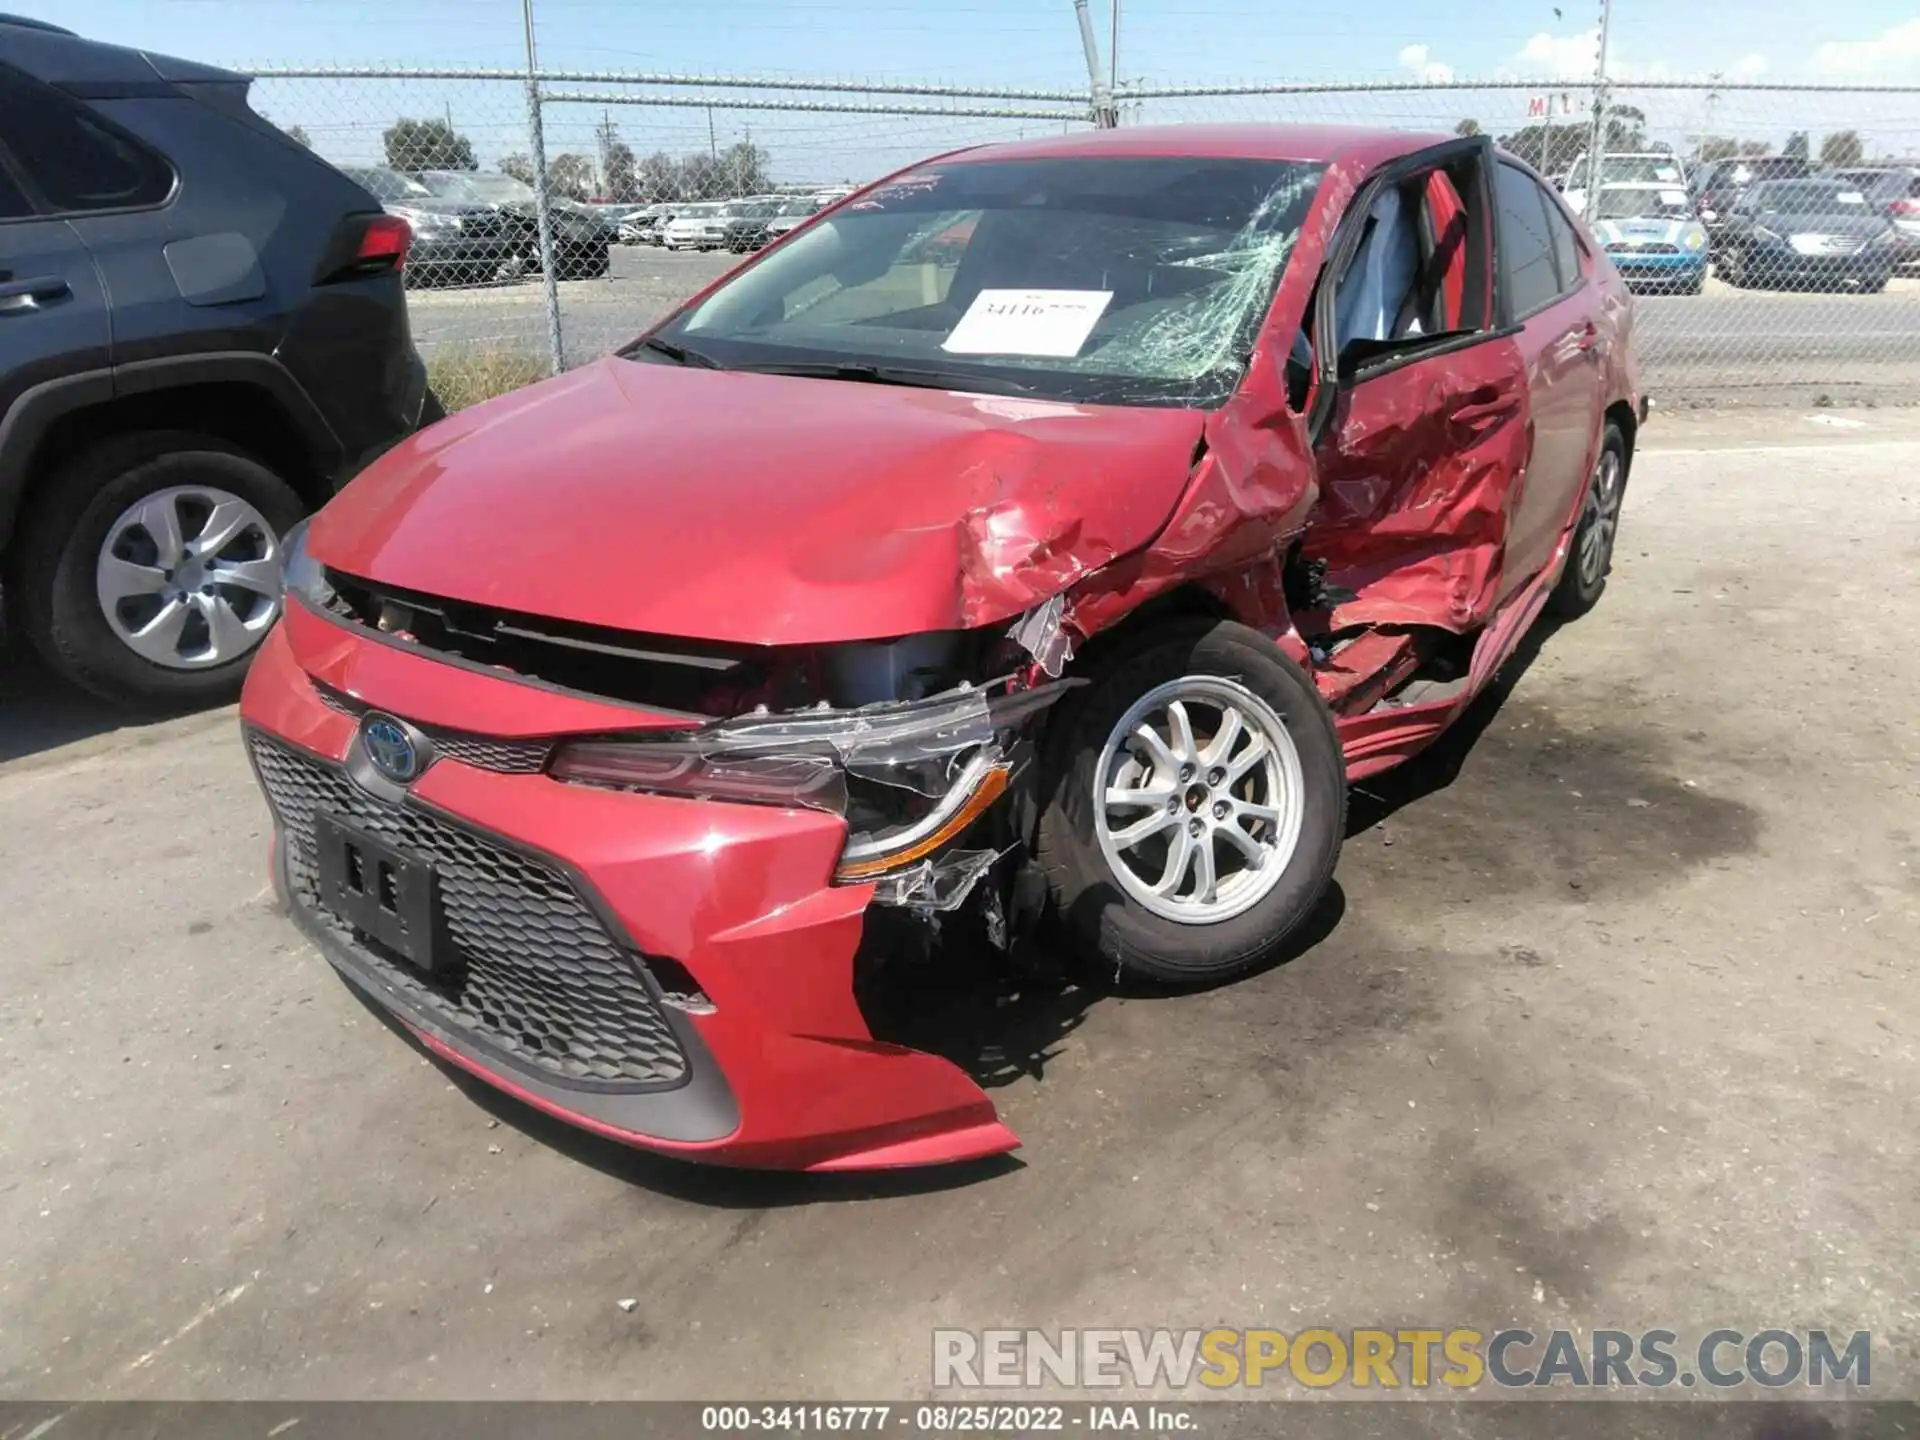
top-left (309, 359), bottom-right (1206, 645)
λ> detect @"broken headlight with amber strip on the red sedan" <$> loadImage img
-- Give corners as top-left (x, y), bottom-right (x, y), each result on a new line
top-left (547, 682), bottom-right (1079, 885)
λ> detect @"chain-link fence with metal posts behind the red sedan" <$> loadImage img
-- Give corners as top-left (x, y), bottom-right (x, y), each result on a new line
top-left (255, 55), bottom-right (1920, 405)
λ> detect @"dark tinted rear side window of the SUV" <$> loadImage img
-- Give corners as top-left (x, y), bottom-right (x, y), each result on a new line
top-left (0, 71), bottom-right (173, 215)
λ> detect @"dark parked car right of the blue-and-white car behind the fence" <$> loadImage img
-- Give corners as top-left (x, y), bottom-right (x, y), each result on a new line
top-left (1715, 177), bottom-right (1901, 294)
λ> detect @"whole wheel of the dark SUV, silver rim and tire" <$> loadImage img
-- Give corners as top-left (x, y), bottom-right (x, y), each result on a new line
top-left (19, 432), bottom-right (307, 708)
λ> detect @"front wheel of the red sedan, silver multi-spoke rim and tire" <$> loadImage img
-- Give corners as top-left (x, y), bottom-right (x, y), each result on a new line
top-left (1037, 622), bottom-right (1346, 985)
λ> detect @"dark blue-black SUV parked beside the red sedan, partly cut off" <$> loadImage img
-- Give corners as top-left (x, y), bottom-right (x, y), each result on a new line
top-left (0, 17), bottom-right (438, 707)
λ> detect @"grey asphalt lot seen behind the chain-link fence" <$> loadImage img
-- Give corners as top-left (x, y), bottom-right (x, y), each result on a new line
top-left (409, 246), bottom-right (1920, 409)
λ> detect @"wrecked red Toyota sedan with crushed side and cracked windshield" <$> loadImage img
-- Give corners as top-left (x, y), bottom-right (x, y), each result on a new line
top-left (242, 127), bottom-right (1645, 1169)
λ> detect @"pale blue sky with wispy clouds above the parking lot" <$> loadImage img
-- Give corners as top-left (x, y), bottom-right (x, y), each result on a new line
top-left (52, 0), bottom-right (1920, 179)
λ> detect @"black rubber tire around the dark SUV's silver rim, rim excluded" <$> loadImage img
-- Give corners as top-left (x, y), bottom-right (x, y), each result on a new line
top-left (15, 430), bottom-right (307, 710)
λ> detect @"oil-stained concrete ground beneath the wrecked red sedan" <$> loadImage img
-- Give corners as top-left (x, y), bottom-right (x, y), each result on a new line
top-left (0, 413), bottom-right (1920, 1398)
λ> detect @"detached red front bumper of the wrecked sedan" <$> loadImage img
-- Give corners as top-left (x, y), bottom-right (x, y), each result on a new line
top-left (240, 618), bottom-right (1018, 1169)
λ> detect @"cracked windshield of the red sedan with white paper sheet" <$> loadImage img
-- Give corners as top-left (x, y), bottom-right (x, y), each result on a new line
top-left (630, 156), bottom-right (1323, 407)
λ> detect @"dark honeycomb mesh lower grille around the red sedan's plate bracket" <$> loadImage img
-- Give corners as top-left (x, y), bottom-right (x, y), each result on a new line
top-left (248, 733), bottom-right (687, 1089)
